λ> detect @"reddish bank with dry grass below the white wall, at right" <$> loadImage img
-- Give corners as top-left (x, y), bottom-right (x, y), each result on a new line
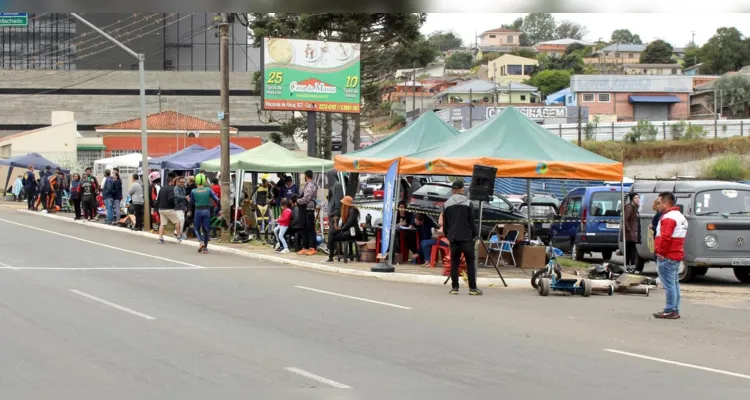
top-left (582, 137), bottom-right (750, 162)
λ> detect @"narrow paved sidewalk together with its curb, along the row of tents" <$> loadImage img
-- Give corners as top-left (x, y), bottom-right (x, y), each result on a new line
top-left (10, 205), bottom-right (576, 290)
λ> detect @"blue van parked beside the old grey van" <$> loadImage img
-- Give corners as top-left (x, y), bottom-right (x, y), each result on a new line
top-left (549, 186), bottom-right (622, 261)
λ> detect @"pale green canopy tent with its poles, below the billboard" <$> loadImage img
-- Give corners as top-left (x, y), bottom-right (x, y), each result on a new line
top-left (200, 142), bottom-right (333, 244)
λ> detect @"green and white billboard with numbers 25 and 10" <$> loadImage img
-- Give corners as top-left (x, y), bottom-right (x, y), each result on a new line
top-left (261, 38), bottom-right (361, 114)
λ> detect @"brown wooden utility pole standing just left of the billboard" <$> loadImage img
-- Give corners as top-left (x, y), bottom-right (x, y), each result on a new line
top-left (219, 13), bottom-right (231, 238)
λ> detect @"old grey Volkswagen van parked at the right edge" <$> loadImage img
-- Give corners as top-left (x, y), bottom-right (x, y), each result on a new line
top-left (631, 178), bottom-right (750, 283)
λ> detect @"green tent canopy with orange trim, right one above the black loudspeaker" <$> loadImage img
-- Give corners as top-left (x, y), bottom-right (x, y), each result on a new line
top-left (399, 107), bottom-right (623, 182)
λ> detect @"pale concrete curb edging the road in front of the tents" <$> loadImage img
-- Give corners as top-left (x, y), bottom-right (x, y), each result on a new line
top-left (18, 210), bottom-right (564, 289)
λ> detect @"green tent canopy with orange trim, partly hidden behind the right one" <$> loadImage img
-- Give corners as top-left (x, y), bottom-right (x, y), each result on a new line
top-left (333, 111), bottom-right (459, 174)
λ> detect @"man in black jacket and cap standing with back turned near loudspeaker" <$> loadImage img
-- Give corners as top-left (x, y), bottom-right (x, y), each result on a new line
top-left (443, 181), bottom-right (482, 296)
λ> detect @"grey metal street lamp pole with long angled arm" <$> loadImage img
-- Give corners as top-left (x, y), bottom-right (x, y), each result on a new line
top-left (70, 13), bottom-right (151, 230)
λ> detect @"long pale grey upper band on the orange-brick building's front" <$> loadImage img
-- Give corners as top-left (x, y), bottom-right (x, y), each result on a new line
top-left (570, 75), bottom-right (693, 93)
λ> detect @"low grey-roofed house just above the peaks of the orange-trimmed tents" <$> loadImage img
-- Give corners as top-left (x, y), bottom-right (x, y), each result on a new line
top-left (435, 79), bottom-right (539, 104)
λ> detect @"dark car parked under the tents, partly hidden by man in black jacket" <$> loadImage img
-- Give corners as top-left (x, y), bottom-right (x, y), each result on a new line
top-left (409, 182), bottom-right (526, 238)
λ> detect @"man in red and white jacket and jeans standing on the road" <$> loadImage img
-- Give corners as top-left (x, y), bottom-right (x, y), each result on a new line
top-left (654, 192), bottom-right (688, 319)
